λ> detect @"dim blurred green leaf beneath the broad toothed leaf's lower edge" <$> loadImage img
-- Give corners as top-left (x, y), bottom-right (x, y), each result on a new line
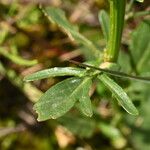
top-left (58, 114), bottom-right (96, 138)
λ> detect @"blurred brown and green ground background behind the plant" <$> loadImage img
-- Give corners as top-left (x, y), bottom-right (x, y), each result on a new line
top-left (0, 0), bottom-right (150, 150)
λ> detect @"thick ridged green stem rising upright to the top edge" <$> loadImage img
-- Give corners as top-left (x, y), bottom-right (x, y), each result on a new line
top-left (104, 0), bottom-right (126, 62)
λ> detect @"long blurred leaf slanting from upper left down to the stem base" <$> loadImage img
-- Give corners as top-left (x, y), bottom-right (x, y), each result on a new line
top-left (43, 7), bottom-right (100, 58)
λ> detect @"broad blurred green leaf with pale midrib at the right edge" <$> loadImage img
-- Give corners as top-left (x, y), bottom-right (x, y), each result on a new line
top-left (130, 20), bottom-right (150, 73)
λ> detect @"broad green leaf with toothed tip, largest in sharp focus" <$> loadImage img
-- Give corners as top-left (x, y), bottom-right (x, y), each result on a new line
top-left (34, 77), bottom-right (94, 121)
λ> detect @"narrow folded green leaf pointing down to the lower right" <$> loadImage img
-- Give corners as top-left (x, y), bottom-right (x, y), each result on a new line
top-left (98, 74), bottom-right (138, 115)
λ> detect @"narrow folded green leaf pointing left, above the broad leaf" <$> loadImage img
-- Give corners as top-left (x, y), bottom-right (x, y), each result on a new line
top-left (24, 67), bottom-right (86, 82)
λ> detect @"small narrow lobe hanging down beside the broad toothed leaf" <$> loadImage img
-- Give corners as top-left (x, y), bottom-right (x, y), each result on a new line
top-left (77, 77), bottom-right (93, 117)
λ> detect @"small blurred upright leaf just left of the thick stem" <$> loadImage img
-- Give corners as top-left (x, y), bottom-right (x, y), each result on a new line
top-left (98, 10), bottom-right (109, 41)
